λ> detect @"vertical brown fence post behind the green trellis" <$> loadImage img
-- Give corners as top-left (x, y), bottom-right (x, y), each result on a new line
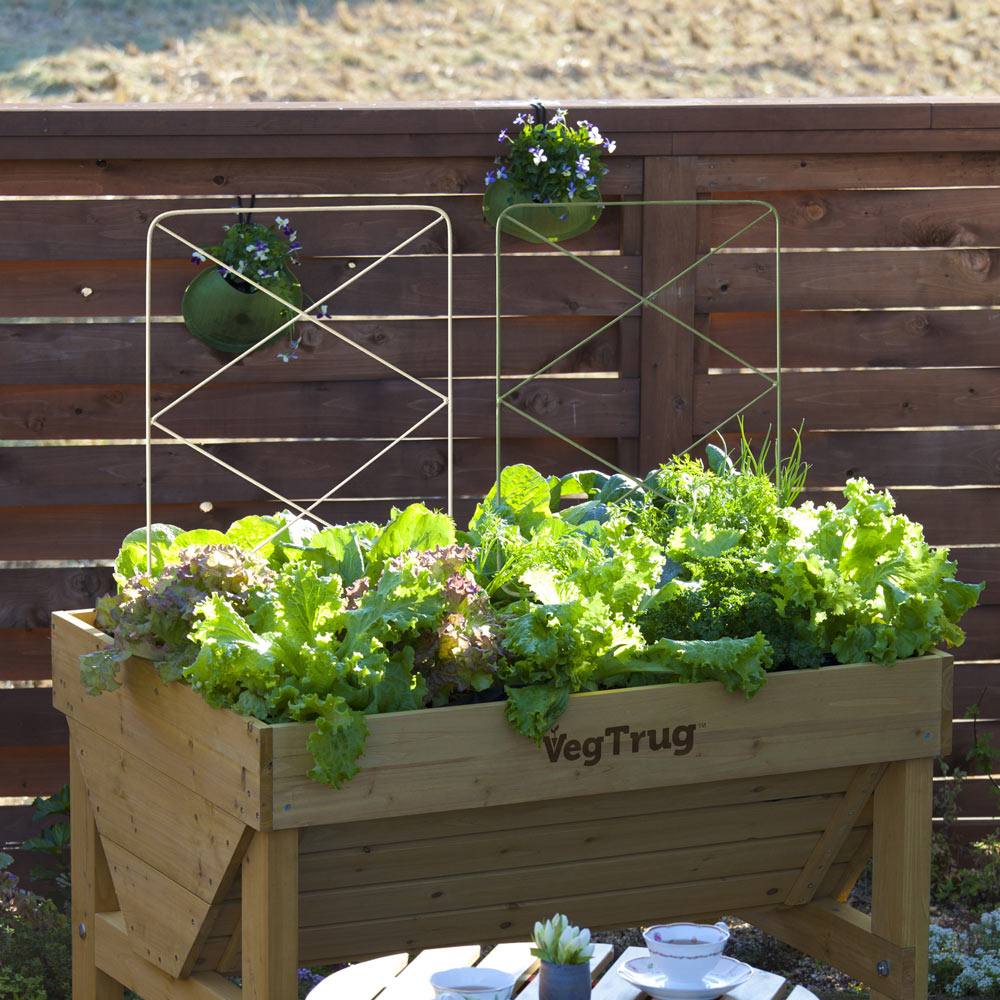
top-left (639, 156), bottom-right (697, 472)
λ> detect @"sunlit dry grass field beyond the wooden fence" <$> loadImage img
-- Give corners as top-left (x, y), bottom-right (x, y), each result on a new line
top-left (0, 0), bottom-right (1000, 102)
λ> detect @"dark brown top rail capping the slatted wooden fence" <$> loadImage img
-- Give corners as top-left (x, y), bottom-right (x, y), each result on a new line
top-left (9, 97), bottom-right (1000, 162)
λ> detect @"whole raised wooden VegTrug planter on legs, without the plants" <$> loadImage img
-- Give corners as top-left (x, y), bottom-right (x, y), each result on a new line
top-left (53, 612), bottom-right (951, 1000)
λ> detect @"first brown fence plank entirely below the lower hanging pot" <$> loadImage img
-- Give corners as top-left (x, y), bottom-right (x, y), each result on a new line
top-left (0, 378), bottom-right (638, 438)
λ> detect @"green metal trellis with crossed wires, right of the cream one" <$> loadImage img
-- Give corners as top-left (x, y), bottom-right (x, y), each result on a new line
top-left (494, 198), bottom-right (781, 496)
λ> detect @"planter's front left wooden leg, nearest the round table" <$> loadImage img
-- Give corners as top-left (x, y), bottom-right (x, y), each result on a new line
top-left (242, 829), bottom-right (299, 1000)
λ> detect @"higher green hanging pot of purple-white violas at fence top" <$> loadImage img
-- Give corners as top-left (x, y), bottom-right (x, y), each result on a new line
top-left (483, 104), bottom-right (615, 243)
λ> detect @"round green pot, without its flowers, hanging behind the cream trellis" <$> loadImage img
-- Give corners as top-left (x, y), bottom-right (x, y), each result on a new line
top-left (181, 267), bottom-right (302, 354)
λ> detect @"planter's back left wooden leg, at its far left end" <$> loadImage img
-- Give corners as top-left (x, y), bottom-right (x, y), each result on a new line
top-left (69, 735), bottom-right (122, 1000)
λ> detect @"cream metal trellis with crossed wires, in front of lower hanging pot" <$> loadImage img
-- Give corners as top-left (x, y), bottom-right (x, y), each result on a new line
top-left (145, 203), bottom-right (454, 566)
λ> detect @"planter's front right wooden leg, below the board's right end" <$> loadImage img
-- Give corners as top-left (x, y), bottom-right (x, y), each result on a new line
top-left (869, 758), bottom-right (933, 1000)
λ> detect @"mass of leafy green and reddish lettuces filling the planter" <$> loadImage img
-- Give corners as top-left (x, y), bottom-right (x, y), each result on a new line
top-left (81, 449), bottom-right (982, 787)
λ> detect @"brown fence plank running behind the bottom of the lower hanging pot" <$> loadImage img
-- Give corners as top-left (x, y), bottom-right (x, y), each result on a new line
top-left (0, 316), bottom-right (630, 385)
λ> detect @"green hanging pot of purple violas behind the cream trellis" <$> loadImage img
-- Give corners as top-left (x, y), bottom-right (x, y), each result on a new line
top-left (181, 214), bottom-right (302, 354)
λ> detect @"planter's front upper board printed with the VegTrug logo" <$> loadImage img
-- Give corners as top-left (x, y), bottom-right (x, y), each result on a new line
top-left (264, 654), bottom-right (942, 828)
